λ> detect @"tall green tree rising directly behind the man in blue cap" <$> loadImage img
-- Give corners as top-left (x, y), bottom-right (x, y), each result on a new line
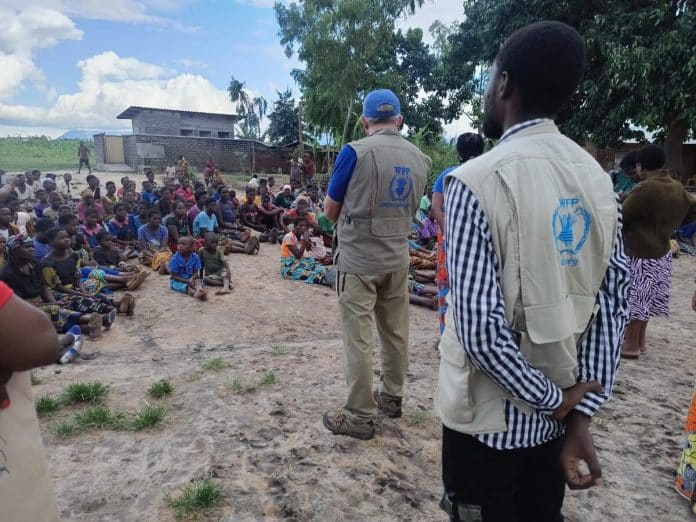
top-left (274, 0), bottom-right (448, 143)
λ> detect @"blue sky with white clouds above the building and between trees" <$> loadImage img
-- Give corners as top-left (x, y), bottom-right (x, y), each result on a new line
top-left (0, 0), bottom-right (462, 137)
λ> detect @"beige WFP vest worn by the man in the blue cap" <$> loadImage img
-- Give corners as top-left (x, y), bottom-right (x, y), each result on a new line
top-left (335, 129), bottom-right (430, 275)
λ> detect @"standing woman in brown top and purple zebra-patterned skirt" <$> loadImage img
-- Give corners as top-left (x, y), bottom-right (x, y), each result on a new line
top-left (621, 145), bottom-right (696, 359)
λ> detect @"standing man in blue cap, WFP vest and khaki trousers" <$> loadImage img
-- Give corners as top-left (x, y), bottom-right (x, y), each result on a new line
top-left (324, 89), bottom-right (430, 440)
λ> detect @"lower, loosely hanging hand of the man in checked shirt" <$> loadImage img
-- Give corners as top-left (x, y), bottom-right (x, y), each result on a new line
top-left (560, 411), bottom-right (602, 489)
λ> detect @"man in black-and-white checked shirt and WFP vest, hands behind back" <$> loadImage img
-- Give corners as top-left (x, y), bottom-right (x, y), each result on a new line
top-left (435, 22), bottom-right (629, 522)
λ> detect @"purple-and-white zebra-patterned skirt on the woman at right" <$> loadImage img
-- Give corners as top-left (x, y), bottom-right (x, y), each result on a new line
top-left (628, 252), bottom-right (672, 321)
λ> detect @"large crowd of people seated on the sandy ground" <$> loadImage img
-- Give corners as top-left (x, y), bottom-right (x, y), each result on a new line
top-left (0, 165), bottom-right (437, 360)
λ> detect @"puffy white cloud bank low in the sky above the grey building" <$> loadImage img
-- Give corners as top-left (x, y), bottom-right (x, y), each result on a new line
top-left (0, 51), bottom-right (234, 129)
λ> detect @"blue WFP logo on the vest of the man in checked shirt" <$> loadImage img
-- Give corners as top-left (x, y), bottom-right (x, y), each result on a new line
top-left (552, 198), bottom-right (592, 266)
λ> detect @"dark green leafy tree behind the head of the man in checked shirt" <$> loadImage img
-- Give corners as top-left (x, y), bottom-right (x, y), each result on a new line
top-left (444, 0), bottom-right (696, 180)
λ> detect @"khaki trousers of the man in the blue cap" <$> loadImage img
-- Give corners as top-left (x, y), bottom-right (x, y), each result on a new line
top-left (336, 268), bottom-right (409, 422)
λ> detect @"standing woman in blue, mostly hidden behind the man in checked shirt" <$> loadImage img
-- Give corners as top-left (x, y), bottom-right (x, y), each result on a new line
top-left (432, 132), bottom-right (483, 333)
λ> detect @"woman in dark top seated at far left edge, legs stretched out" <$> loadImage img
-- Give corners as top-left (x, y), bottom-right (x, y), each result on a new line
top-left (0, 235), bottom-right (104, 336)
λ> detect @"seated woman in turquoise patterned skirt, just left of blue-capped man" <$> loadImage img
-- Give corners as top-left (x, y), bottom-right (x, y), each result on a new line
top-left (280, 218), bottom-right (328, 284)
